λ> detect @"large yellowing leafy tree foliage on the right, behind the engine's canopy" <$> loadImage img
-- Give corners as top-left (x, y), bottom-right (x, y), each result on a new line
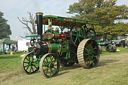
top-left (67, 0), bottom-right (128, 39)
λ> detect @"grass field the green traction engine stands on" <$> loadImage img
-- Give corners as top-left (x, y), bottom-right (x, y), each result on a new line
top-left (0, 48), bottom-right (128, 85)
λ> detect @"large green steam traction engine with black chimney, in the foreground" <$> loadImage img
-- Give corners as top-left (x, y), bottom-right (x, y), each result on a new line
top-left (22, 12), bottom-right (100, 78)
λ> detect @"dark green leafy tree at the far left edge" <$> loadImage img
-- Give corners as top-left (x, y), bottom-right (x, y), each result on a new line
top-left (0, 12), bottom-right (11, 39)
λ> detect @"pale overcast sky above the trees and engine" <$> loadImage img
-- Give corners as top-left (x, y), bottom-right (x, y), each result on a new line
top-left (0, 0), bottom-right (128, 40)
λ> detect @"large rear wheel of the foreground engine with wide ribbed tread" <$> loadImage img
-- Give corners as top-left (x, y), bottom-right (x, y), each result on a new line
top-left (77, 39), bottom-right (100, 68)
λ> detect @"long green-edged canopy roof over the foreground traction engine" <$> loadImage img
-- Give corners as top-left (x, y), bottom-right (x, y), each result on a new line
top-left (35, 15), bottom-right (102, 27)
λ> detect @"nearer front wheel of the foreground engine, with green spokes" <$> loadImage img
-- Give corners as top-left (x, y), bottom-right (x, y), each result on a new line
top-left (40, 53), bottom-right (60, 78)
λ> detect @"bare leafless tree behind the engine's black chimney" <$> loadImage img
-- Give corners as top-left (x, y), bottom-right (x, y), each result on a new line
top-left (17, 12), bottom-right (36, 34)
